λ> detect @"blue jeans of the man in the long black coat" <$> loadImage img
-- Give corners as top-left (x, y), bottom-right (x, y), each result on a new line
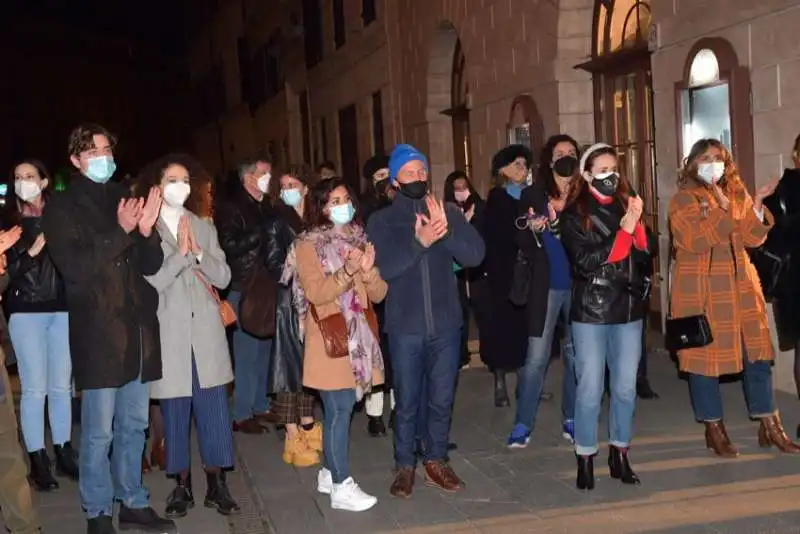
top-left (79, 379), bottom-right (150, 519)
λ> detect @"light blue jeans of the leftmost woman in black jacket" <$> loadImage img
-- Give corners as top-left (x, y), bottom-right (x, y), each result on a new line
top-left (8, 312), bottom-right (72, 452)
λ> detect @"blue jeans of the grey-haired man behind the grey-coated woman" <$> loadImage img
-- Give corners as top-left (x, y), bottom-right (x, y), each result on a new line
top-left (228, 291), bottom-right (272, 421)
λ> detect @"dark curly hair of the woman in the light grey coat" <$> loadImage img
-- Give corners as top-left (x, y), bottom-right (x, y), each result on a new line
top-left (133, 154), bottom-right (213, 217)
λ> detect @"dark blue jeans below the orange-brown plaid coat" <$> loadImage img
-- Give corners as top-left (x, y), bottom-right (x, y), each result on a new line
top-left (689, 358), bottom-right (775, 422)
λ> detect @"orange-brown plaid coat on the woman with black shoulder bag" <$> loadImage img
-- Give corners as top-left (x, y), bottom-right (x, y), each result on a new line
top-left (669, 180), bottom-right (775, 376)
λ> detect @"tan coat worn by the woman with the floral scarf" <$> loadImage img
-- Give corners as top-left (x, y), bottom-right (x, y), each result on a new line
top-left (295, 240), bottom-right (387, 391)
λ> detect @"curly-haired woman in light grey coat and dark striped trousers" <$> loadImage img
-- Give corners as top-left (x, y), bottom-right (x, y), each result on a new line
top-left (137, 154), bottom-right (239, 517)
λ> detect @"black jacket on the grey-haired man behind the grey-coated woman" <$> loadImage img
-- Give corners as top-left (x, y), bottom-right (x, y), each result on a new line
top-left (214, 187), bottom-right (271, 291)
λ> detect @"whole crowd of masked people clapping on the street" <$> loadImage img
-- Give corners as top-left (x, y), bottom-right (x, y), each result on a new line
top-left (0, 124), bottom-right (800, 534)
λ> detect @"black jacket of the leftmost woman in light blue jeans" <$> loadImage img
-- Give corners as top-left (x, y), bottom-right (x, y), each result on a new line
top-left (5, 217), bottom-right (67, 314)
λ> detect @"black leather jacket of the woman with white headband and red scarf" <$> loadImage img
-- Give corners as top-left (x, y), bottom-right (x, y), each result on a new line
top-left (561, 197), bottom-right (656, 324)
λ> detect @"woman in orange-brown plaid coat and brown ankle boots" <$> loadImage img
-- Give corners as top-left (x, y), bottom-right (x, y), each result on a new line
top-left (669, 139), bottom-right (800, 457)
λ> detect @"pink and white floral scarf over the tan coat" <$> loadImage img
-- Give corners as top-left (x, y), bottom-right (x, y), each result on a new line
top-left (280, 225), bottom-right (383, 400)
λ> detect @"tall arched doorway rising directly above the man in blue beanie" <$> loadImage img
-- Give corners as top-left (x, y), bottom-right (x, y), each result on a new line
top-left (425, 21), bottom-right (480, 195)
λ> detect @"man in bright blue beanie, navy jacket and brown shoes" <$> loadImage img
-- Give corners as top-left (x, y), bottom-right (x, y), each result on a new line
top-left (367, 145), bottom-right (484, 497)
